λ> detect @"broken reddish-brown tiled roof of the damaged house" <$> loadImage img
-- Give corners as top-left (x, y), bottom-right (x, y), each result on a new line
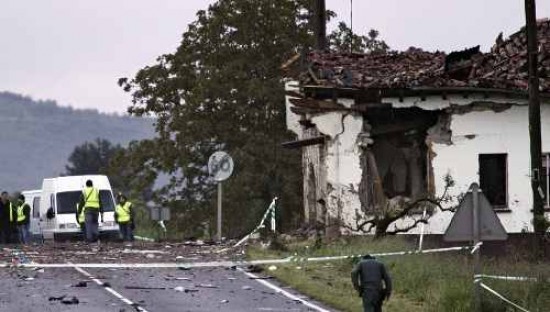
top-left (299, 19), bottom-right (550, 92)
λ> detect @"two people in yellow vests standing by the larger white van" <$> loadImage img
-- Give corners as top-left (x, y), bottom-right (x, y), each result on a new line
top-left (76, 180), bottom-right (135, 243)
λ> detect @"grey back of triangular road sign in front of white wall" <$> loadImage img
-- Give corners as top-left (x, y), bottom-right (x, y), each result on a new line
top-left (443, 183), bottom-right (508, 242)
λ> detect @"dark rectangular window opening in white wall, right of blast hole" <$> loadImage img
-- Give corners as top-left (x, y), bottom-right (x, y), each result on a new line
top-left (479, 154), bottom-right (508, 208)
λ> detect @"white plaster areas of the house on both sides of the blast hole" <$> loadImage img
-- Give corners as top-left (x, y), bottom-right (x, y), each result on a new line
top-left (287, 83), bottom-right (550, 234)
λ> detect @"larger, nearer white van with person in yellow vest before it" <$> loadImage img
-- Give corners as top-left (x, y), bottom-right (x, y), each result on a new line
top-left (40, 175), bottom-right (118, 240)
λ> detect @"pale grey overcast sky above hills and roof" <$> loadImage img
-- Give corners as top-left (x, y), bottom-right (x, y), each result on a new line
top-left (0, 0), bottom-right (550, 113)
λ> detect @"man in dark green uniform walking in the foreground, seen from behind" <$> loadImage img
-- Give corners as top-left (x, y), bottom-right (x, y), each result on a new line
top-left (351, 255), bottom-right (392, 312)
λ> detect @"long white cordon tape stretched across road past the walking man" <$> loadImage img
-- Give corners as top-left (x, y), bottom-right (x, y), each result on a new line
top-left (0, 246), bottom-right (471, 269)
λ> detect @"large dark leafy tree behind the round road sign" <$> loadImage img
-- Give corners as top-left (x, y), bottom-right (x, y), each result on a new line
top-left (119, 0), bottom-right (312, 236)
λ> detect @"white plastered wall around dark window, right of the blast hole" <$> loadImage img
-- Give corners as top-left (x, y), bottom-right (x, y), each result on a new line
top-left (393, 97), bottom-right (550, 234)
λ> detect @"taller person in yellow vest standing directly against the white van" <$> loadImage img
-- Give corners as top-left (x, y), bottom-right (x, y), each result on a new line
top-left (79, 180), bottom-right (103, 243)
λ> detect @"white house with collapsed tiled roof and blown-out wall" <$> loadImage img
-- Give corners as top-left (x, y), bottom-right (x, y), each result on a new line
top-left (284, 20), bottom-right (550, 234)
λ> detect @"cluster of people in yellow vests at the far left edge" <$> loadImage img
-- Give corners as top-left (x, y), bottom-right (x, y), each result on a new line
top-left (0, 192), bottom-right (31, 244)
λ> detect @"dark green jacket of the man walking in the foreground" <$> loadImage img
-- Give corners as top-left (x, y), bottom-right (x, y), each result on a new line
top-left (351, 256), bottom-right (392, 297)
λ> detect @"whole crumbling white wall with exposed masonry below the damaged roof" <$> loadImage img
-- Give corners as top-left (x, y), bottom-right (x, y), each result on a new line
top-left (287, 83), bottom-right (550, 234)
